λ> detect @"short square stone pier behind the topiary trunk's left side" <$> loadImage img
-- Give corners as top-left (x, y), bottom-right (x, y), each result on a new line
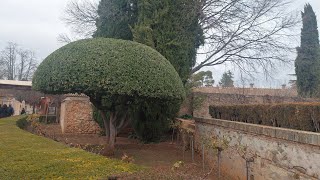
top-left (60, 95), bottom-right (100, 134)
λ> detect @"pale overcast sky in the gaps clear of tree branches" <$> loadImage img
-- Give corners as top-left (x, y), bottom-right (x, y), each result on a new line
top-left (0, 0), bottom-right (320, 87)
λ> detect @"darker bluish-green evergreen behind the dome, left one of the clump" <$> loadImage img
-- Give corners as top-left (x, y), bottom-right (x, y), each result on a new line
top-left (93, 0), bottom-right (137, 40)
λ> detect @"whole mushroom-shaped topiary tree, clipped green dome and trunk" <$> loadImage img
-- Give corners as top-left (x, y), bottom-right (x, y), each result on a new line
top-left (33, 38), bottom-right (185, 149)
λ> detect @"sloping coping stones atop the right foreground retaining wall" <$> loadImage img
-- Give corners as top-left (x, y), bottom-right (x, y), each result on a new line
top-left (194, 117), bottom-right (320, 146)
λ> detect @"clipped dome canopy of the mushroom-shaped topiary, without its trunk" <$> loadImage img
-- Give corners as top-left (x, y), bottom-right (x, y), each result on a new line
top-left (32, 38), bottom-right (184, 99)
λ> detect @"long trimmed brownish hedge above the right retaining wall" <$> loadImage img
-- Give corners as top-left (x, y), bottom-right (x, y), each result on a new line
top-left (209, 103), bottom-right (320, 131)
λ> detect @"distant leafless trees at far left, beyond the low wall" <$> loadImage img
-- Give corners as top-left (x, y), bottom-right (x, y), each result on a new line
top-left (0, 42), bottom-right (37, 81)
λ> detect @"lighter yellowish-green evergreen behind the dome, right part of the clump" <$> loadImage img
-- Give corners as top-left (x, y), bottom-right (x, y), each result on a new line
top-left (132, 0), bottom-right (204, 82)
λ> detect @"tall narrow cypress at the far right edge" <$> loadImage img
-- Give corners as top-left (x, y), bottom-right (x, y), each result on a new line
top-left (295, 4), bottom-right (320, 97)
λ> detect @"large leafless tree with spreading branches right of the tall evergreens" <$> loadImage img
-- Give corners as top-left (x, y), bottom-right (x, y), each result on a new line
top-left (192, 0), bottom-right (299, 74)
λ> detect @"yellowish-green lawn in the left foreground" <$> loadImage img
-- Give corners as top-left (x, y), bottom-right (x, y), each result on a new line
top-left (0, 117), bottom-right (140, 180)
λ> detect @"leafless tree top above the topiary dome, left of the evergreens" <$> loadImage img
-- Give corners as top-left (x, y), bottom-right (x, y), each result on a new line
top-left (59, 0), bottom-right (98, 38)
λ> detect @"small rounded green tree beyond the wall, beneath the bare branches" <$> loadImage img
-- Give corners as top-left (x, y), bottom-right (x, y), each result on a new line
top-left (189, 71), bottom-right (214, 87)
